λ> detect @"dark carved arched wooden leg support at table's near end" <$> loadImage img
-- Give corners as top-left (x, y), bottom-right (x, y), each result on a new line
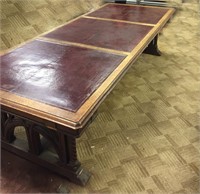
top-left (1, 111), bottom-right (91, 185)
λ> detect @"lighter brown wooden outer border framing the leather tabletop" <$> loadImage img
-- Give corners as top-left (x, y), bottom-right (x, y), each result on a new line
top-left (0, 4), bottom-right (175, 130)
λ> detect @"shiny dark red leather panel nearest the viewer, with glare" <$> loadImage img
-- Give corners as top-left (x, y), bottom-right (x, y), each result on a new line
top-left (1, 40), bottom-right (124, 111)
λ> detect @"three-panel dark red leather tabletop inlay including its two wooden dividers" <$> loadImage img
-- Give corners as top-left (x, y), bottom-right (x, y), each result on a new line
top-left (0, 4), bottom-right (173, 116)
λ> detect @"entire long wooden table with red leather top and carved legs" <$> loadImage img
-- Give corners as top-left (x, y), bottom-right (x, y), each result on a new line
top-left (0, 4), bottom-right (174, 185)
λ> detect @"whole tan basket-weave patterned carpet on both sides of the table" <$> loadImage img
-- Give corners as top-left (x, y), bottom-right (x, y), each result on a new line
top-left (1, 0), bottom-right (200, 194)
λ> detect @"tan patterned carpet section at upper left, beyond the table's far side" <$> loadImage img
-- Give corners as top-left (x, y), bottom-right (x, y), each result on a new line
top-left (0, 0), bottom-right (102, 50)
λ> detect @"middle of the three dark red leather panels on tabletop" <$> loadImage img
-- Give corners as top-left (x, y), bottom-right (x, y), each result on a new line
top-left (45, 18), bottom-right (152, 52)
